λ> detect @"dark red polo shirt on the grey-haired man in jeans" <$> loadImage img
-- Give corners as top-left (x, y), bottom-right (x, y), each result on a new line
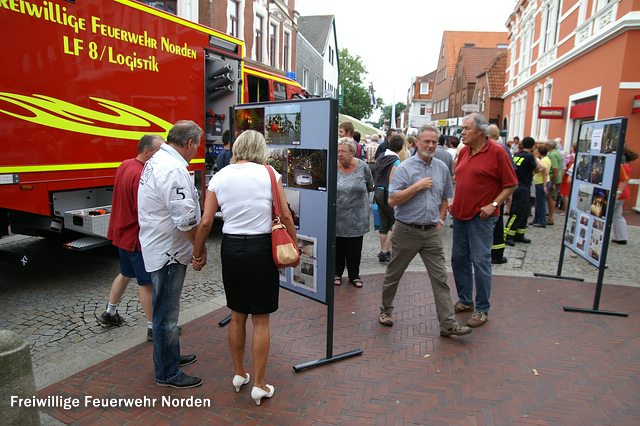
top-left (451, 139), bottom-right (518, 220)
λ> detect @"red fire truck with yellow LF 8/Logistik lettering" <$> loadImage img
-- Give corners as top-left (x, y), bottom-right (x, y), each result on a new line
top-left (0, 0), bottom-right (244, 247)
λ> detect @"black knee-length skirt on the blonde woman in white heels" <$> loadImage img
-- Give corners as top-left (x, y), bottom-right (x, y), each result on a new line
top-left (221, 234), bottom-right (280, 314)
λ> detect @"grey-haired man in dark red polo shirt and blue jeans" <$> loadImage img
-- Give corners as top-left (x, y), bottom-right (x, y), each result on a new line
top-left (450, 113), bottom-right (518, 327)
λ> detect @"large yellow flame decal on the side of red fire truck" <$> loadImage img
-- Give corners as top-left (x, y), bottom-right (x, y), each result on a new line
top-left (0, 92), bottom-right (172, 140)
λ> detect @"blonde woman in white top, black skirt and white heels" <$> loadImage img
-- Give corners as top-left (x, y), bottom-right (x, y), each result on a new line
top-left (193, 130), bottom-right (296, 405)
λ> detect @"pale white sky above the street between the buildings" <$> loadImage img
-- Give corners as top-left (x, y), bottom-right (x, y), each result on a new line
top-left (295, 0), bottom-right (516, 104)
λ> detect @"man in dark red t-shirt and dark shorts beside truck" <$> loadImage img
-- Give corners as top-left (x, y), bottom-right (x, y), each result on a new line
top-left (98, 135), bottom-right (164, 340)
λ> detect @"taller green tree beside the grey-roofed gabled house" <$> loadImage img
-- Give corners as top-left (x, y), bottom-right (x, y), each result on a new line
top-left (338, 49), bottom-right (372, 120)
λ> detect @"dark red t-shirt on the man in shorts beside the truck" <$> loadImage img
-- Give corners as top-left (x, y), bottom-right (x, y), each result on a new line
top-left (107, 158), bottom-right (144, 251)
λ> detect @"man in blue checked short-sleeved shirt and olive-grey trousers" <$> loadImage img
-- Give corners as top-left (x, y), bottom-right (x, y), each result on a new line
top-left (379, 126), bottom-right (471, 337)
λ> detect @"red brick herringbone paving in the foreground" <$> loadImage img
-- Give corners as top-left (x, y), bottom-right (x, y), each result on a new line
top-left (38, 273), bottom-right (640, 426)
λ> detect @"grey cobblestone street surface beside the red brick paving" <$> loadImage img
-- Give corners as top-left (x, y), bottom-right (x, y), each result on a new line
top-left (0, 212), bottom-right (640, 388)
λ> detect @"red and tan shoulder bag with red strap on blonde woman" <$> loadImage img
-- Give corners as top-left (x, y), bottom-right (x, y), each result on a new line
top-left (265, 165), bottom-right (300, 268)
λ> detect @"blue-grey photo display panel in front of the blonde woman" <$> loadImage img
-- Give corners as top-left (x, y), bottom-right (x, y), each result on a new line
top-left (232, 98), bottom-right (338, 304)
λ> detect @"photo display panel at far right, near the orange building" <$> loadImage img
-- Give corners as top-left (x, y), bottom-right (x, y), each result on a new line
top-left (564, 118), bottom-right (627, 268)
